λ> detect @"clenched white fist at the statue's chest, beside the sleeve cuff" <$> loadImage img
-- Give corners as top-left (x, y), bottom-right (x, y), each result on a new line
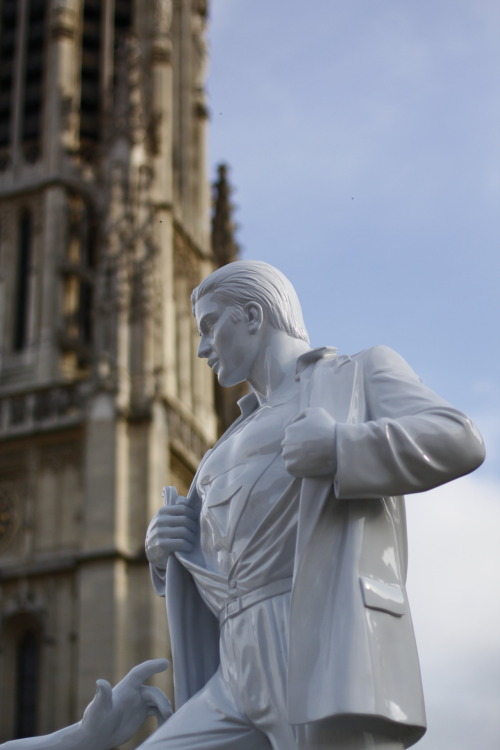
top-left (281, 406), bottom-right (337, 477)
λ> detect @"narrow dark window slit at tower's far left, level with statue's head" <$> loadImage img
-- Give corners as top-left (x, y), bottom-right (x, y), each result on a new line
top-left (12, 211), bottom-right (33, 352)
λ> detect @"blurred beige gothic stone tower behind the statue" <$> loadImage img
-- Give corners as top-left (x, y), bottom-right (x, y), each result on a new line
top-left (0, 0), bottom-right (231, 740)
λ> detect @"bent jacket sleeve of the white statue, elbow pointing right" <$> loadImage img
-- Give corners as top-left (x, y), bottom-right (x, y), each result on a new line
top-left (335, 346), bottom-right (484, 499)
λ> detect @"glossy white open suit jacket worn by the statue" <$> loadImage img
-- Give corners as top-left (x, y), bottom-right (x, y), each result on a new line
top-left (152, 346), bottom-right (484, 746)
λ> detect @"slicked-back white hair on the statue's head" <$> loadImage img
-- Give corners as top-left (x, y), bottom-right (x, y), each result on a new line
top-left (191, 260), bottom-right (309, 343)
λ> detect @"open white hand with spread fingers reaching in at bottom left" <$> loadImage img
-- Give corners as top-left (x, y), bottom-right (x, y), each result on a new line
top-left (81, 659), bottom-right (172, 750)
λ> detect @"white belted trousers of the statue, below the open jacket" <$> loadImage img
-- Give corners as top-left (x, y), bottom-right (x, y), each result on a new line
top-left (141, 593), bottom-right (403, 750)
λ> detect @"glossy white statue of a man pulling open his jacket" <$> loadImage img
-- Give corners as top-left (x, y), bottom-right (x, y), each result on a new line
top-left (142, 261), bottom-right (484, 750)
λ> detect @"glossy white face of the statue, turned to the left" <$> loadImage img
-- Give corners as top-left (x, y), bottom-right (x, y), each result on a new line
top-left (194, 294), bottom-right (259, 388)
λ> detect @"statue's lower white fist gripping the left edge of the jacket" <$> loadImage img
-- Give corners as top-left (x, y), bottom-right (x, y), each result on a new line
top-left (145, 496), bottom-right (198, 568)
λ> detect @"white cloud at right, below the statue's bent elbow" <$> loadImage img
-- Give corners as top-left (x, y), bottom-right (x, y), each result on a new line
top-left (407, 476), bottom-right (500, 750)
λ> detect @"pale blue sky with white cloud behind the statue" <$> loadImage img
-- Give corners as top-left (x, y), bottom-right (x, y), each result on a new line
top-left (208, 0), bottom-right (500, 750)
